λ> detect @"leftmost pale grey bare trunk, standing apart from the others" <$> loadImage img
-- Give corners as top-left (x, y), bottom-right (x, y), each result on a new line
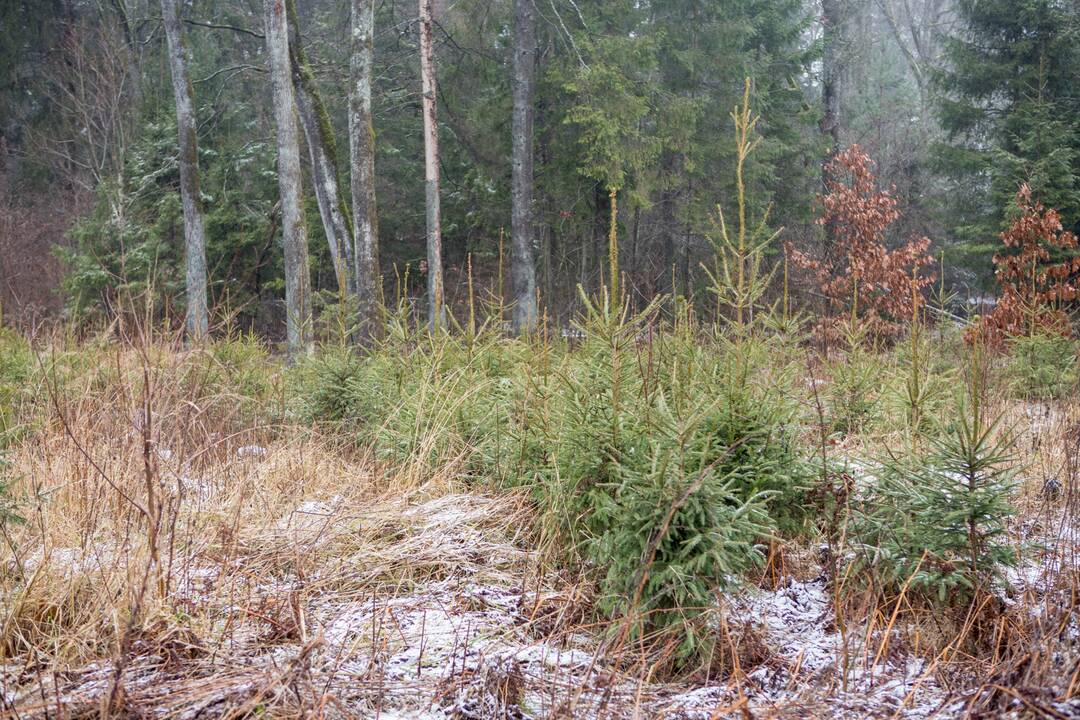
top-left (161, 0), bottom-right (208, 338)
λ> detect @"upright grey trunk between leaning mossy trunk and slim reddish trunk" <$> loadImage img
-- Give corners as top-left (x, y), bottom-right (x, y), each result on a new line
top-left (349, 0), bottom-right (381, 339)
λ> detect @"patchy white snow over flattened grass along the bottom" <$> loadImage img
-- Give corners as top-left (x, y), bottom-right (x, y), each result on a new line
top-left (0, 494), bottom-right (1080, 720)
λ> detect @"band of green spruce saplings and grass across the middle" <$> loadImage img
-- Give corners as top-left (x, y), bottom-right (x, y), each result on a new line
top-left (0, 296), bottom-right (1069, 703)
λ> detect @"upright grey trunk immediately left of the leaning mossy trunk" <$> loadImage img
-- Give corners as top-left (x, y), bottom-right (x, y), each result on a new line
top-left (264, 0), bottom-right (311, 354)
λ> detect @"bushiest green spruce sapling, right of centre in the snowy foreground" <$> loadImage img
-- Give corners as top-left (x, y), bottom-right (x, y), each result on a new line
top-left (596, 398), bottom-right (772, 663)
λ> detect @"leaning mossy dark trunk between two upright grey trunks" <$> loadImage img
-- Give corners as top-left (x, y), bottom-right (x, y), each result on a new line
top-left (285, 0), bottom-right (355, 296)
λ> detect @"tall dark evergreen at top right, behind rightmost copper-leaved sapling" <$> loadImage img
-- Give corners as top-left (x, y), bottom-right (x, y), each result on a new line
top-left (936, 0), bottom-right (1080, 275)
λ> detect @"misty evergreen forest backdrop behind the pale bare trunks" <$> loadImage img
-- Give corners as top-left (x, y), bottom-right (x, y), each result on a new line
top-left (0, 0), bottom-right (1080, 337)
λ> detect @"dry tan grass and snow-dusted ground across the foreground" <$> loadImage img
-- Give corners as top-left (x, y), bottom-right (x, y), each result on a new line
top-left (0, 345), bottom-right (1080, 720)
